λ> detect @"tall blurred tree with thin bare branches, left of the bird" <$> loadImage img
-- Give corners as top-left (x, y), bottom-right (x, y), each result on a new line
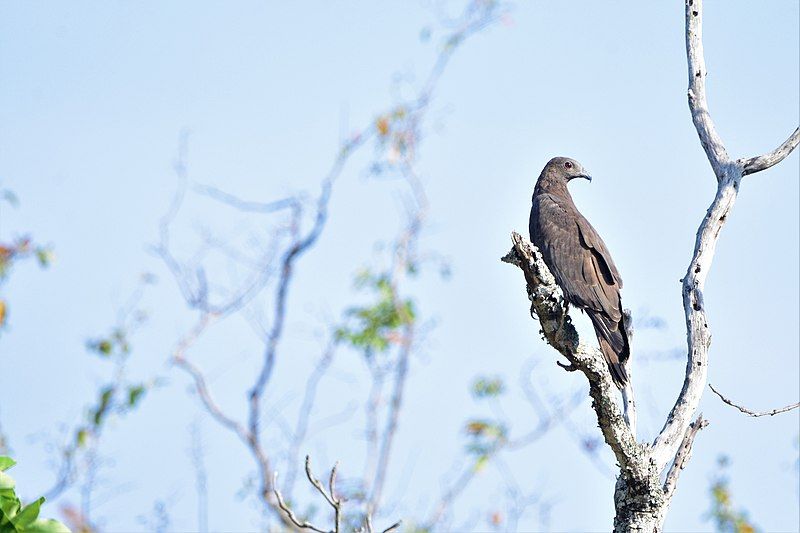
top-left (154, 0), bottom-right (550, 531)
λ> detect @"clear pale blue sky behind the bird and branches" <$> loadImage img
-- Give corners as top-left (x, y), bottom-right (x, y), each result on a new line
top-left (0, 0), bottom-right (800, 531)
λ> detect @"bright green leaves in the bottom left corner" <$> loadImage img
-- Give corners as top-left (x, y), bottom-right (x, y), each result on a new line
top-left (0, 456), bottom-right (69, 533)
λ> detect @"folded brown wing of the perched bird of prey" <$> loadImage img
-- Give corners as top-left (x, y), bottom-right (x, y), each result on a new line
top-left (531, 194), bottom-right (622, 323)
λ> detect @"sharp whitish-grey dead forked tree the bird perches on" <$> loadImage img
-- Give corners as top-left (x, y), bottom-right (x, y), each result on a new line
top-left (503, 0), bottom-right (800, 532)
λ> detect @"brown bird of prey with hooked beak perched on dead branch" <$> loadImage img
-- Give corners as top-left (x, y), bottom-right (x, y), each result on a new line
top-left (529, 157), bottom-right (630, 389)
